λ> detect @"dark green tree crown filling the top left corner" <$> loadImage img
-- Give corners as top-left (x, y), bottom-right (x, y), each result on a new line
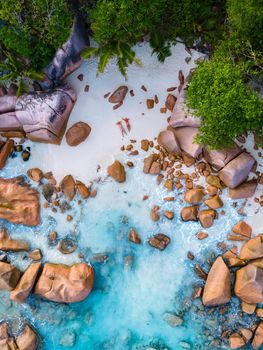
top-left (0, 0), bottom-right (72, 70)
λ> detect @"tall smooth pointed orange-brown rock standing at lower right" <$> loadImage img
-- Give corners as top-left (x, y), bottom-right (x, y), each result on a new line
top-left (203, 257), bottom-right (231, 306)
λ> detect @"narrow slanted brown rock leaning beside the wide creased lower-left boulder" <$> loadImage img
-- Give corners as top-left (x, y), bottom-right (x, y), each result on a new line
top-left (10, 262), bottom-right (41, 303)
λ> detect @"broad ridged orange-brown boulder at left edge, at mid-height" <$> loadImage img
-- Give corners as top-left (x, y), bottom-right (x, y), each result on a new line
top-left (0, 177), bottom-right (40, 226)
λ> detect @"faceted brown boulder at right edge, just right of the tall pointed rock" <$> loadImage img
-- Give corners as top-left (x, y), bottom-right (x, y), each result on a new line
top-left (234, 264), bottom-right (263, 304)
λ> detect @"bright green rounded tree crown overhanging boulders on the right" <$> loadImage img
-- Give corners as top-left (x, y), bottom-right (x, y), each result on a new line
top-left (187, 57), bottom-right (263, 149)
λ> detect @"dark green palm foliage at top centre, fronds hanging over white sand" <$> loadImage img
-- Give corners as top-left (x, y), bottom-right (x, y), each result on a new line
top-left (83, 0), bottom-right (224, 75)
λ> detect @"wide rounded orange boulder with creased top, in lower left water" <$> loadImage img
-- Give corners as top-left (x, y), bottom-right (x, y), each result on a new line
top-left (35, 263), bottom-right (94, 303)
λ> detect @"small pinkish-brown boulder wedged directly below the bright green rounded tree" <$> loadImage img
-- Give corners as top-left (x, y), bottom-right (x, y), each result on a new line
top-left (204, 144), bottom-right (242, 170)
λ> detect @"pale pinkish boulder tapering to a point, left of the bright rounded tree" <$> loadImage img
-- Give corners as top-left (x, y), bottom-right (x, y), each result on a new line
top-left (169, 77), bottom-right (200, 128)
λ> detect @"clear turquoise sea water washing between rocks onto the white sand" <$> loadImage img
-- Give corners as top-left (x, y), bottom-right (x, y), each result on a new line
top-left (0, 144), bottom-right (252, 350)
